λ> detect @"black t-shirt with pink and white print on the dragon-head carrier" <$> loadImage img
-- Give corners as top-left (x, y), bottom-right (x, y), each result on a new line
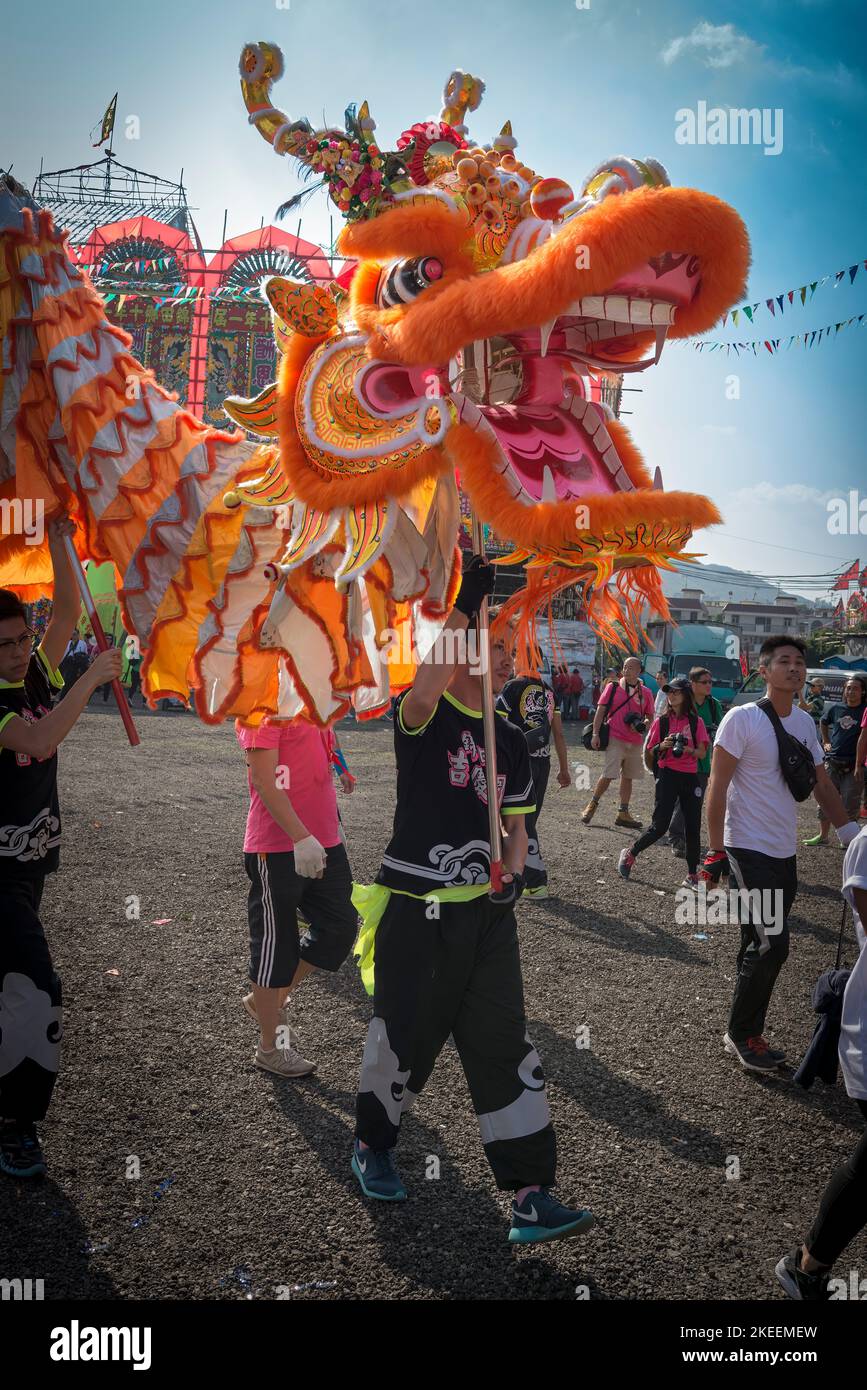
top-left (377, 691), bottom-right (535, 897)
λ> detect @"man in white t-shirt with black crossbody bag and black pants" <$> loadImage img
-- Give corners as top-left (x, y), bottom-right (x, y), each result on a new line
top-left (703, 637), bottom-right (859, 1072)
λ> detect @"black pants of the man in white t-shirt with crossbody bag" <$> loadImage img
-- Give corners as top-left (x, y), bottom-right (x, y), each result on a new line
top-left (725, 845), bottom-right (798, 1043)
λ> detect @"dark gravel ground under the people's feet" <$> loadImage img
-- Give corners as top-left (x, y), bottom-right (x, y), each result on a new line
top-left (0, 709), bottom-right (867, 1300)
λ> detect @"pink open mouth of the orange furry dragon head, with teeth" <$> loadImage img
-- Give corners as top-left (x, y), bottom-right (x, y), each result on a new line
top-left (354, 253), bottom-right (700, 506)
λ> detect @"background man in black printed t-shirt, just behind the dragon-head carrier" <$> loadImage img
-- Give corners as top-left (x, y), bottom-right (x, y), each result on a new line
top-left (497, 664), bottom-right (572, 898)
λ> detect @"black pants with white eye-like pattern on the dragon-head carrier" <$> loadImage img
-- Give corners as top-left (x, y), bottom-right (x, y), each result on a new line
top-left (356, 892), bottom-right (556, 1191)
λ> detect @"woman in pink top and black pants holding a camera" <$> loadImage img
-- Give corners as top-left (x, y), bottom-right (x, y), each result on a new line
top-left (617, 676), bottom-right (710, 888)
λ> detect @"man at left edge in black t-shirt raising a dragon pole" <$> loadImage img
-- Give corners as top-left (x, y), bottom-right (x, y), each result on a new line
top-left (0, 518), bottom-right (121, 1177)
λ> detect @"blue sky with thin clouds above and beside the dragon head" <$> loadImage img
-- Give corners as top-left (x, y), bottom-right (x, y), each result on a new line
top-left (0, 0), bottom-right (867, 591)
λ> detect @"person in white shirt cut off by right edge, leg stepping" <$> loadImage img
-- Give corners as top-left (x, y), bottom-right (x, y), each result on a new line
top-left (777, 826), bottom-right (867, 1302)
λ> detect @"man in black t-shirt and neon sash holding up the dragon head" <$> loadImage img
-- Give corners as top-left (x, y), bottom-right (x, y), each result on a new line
top-left (352, 557), bottom-right (593, 1244)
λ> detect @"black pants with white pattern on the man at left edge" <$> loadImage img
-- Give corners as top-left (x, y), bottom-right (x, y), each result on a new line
top-left (0, 874), bottom-right (63, 1122)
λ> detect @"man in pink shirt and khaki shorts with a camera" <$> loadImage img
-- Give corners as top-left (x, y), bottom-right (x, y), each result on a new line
top-left (581, 656), bottom-right (653, 830)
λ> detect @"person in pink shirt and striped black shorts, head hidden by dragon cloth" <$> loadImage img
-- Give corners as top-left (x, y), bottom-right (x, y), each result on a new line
top-left (236, 721), bottom-right (358, 1076)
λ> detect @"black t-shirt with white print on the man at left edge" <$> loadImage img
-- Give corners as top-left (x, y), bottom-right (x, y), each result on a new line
top-left (0, 652), bottom-right (63, 881)
